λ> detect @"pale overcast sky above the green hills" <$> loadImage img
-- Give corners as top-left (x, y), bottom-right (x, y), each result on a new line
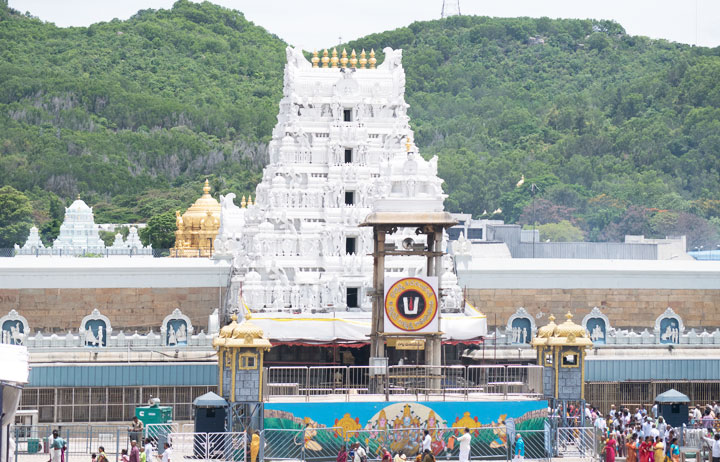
top-left (9, 0), bottom-right (720, 50)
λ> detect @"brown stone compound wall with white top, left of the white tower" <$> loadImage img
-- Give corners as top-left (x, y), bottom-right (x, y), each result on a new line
top-left (0, 257), bottom-right (229, 333)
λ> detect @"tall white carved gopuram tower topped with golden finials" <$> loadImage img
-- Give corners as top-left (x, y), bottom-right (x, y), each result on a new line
top-left (214, 47), bottom-right (462, 314)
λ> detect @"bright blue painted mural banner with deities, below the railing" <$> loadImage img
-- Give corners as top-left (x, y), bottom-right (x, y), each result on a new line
top-left (264, 401), bottom-right (547, 460)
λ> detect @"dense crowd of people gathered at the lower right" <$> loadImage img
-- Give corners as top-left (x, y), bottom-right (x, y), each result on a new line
top-left (567, 401), bottom-right (720, 462)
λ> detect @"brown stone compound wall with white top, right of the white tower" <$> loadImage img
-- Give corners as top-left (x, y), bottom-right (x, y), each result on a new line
top-left (458, 257), bottom-right (720, 330)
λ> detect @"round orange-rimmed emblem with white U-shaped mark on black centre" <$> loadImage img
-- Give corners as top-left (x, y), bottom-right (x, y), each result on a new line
top-left (385, 278), bottom-right (438, 332)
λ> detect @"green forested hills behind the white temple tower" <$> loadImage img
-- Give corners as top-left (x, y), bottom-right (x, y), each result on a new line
top-left (0, 0), bottom-right (720, 246)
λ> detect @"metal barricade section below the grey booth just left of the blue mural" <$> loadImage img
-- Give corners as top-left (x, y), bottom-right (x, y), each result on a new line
top-left (168, 432), bottom-right (247, 462)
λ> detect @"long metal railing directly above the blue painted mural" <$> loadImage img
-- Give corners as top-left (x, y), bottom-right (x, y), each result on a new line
top-left (264, 365), bottom-right (543, 401)
